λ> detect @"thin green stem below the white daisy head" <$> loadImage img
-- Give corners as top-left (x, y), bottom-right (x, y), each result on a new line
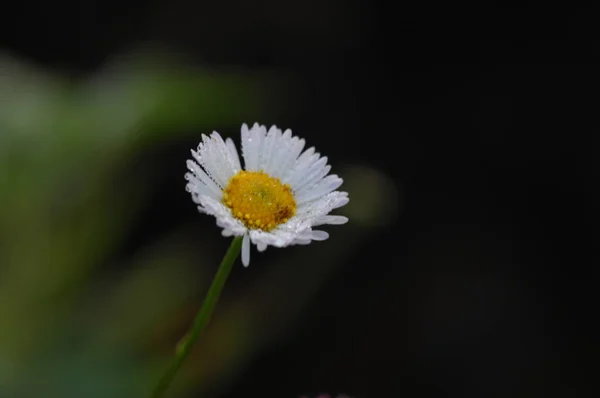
top-left (152, 236), bottom-right (242, 398)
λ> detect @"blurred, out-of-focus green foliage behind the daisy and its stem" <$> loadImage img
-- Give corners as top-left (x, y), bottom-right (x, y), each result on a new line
top-left (0, 48), bottom-right (395, 398)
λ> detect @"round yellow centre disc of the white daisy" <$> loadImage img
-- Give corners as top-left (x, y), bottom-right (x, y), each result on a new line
top-left (222, 170), bottom-right (296, 231)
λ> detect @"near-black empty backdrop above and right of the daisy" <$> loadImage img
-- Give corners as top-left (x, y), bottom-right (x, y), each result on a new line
top-left (0, 0), bottom-right (600, 398)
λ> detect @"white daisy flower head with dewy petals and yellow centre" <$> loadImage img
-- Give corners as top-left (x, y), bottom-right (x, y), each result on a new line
top-left (185, 123), bottom-right (349, 266)
